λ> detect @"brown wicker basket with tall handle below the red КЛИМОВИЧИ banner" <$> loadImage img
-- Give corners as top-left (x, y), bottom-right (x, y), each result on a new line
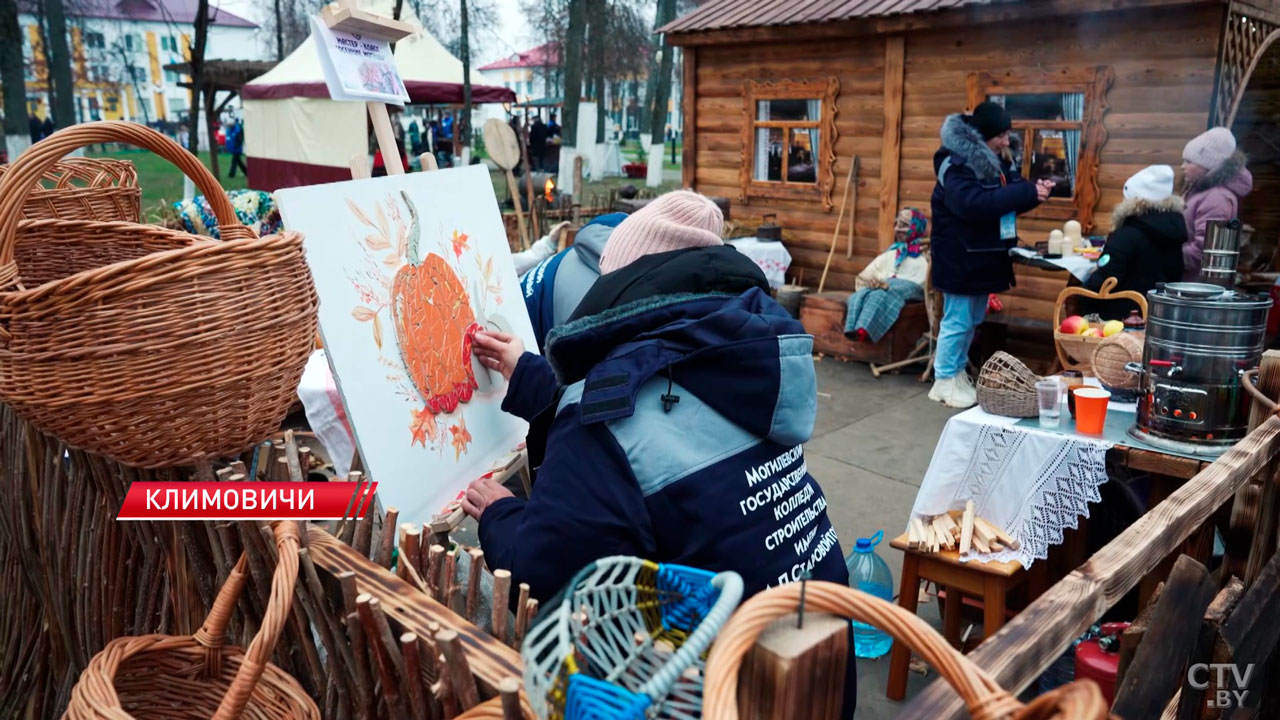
top-left (63, 521), bottom-right (320, 720)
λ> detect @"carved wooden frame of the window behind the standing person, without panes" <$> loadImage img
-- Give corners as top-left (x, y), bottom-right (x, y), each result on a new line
top-left (965, 65), bottom-right (1115, 232)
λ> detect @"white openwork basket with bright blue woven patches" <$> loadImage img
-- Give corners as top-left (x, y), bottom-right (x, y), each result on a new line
top-left (520, 556), bottom-right (742, 720)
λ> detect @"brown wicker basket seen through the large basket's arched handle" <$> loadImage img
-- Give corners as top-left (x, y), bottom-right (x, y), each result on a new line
top-left (0, 158), bottom-right (142, 223)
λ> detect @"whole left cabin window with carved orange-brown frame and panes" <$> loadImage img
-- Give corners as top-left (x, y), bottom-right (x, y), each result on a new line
top-left (740, 78), bottom-right (840, 210)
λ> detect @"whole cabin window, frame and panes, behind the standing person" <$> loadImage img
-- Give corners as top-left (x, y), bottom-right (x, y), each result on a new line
top-left (966, 65), bottom-right (1115, 226)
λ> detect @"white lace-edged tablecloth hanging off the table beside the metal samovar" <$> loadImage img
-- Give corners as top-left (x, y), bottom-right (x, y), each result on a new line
top-left (911, 384), bottom-right (1134, 568)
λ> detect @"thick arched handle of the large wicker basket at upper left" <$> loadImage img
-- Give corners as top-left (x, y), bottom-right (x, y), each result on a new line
top-left (0, 120), bottom-right (257, 280)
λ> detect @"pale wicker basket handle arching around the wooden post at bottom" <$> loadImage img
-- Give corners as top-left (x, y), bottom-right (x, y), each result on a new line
top-left (703, 582), bottom-right (1110, 720)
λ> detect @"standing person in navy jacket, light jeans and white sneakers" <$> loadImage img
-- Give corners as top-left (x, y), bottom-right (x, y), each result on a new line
top-left (929, 101), bottom-right (1053, 407)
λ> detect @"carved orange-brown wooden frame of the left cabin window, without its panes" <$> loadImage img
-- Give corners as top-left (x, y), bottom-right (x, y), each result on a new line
top-left (739, 77), bottom-right (840, 213)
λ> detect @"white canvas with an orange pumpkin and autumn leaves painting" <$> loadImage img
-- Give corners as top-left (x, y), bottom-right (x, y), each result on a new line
top-left (275, 165), bottom-right (536, 523)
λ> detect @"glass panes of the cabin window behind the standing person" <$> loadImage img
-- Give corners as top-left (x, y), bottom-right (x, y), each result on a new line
top-left (987, 92), bottom-right (1084, 199)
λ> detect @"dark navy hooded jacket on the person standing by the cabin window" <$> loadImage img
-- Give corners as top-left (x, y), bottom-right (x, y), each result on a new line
top-left (931, 114), bottom-right (1039, 295)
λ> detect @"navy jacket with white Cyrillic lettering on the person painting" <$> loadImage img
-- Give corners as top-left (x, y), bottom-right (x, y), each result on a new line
top-left (480, 249), bottom-right (849, 600)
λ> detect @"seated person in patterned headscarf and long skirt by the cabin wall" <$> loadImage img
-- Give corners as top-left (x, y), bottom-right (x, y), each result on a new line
top-left (845, 208), bottom-right (929, 342)
